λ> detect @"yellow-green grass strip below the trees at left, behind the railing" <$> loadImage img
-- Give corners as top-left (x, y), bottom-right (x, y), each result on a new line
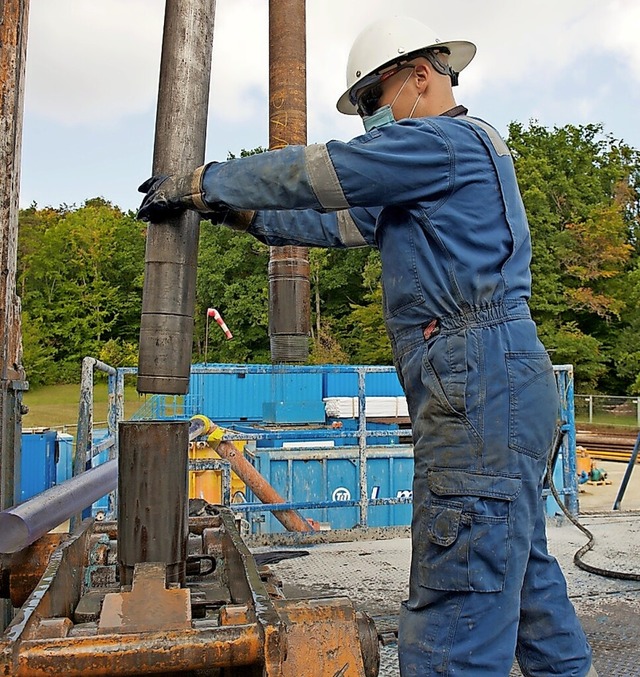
top-left (22, 379), bottom-right (145, 434)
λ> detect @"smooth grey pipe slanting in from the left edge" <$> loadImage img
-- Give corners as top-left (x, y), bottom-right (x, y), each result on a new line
top-left (0, 460), bottom-right (118, 553)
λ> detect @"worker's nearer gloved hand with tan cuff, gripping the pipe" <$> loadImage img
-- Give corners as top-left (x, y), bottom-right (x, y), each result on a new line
top-left (137, 165), bottom-right (211, 223)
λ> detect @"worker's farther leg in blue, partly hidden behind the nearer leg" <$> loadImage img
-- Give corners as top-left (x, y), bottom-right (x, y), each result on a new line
top-left (516, 494), bottom-right (593, 677)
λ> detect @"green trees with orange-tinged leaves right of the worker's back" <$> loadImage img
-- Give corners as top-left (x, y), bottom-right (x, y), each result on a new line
top-left (509, 122), bottom-right (640, 390)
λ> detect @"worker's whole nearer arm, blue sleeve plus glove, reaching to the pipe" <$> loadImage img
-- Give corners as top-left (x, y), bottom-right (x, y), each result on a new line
top-left (138, 119), bottom-right (453, 236)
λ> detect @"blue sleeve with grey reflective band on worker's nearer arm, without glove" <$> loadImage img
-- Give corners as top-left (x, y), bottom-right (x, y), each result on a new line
top-left (195, 118), bottom-right (450, 212)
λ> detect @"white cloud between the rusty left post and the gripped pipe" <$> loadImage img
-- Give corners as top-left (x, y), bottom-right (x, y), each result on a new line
top-left (25, 0), bottom-right (163, 125)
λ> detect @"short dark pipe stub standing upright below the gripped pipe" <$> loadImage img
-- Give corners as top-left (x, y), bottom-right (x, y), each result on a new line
top-left (118, 421), bottom-right (189, 586)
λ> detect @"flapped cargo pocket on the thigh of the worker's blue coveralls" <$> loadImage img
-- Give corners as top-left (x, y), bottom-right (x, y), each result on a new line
top-left (420, 468), bottom-right (521, 592)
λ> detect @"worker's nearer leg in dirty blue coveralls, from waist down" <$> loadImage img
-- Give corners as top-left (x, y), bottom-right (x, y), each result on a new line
top-left (398, 322), bottom-right (590, 677)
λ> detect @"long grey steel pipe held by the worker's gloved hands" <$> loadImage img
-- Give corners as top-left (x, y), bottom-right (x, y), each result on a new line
top-left (137, 0), bottom-right (215, 395)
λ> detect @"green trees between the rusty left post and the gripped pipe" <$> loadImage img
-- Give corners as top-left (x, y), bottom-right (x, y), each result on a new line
top-left (18, 199), bottom-right (145, 383)
